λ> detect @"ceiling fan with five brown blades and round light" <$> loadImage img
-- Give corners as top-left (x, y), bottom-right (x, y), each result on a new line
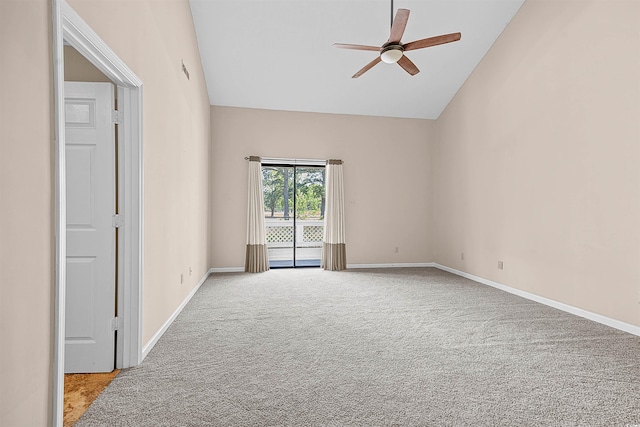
top-left (334, 0), bottom-right (461, 79)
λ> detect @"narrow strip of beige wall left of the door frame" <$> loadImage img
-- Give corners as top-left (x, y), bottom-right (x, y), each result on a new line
top-left (0, 0), bottom-right (54, 427)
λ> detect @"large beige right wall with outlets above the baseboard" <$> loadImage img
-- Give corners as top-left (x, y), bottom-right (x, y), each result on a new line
top-left (434, 0), bottom-right (640, 325)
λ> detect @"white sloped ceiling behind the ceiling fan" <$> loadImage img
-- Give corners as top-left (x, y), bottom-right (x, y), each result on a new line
top-left (190, 0), bottom-right (524, 119)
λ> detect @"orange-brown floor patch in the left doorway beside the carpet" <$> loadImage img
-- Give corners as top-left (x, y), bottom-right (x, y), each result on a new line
top-left (63, 369), bottom-right (120, 427)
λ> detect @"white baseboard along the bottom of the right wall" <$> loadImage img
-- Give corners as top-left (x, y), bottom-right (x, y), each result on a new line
top-left (434, 263), bottom-right (640, 336)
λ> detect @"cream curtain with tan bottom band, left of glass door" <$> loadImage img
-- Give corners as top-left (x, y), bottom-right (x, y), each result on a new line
top-left (244, 156), bottom-right (269, 273)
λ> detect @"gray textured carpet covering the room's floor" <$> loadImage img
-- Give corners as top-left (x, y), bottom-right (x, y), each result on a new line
top-left (76, 268), bottom-right (640, 426)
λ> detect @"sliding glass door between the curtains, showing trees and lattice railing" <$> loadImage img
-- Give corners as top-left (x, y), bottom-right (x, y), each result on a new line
top-left (262, 164), bottom-right (325, 268)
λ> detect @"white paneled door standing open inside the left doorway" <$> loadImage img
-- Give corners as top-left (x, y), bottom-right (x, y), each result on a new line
top-left (64, 82), bottom-right (117, 373)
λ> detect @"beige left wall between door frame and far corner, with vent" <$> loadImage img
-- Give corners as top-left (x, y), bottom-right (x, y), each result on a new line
top-left (69, 0), bottom-right (210, 343)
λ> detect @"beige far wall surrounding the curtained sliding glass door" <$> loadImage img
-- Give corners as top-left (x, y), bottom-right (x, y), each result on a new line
top-left (211, 107), bottom-right (434, 268)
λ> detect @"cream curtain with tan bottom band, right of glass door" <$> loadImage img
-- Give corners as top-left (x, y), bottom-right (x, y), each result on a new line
top-left (322, 160), bottom-right (347, 270)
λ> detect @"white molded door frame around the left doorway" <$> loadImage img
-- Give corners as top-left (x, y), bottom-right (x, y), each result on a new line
top-left (51, 0), bottom-right (144, 427)
